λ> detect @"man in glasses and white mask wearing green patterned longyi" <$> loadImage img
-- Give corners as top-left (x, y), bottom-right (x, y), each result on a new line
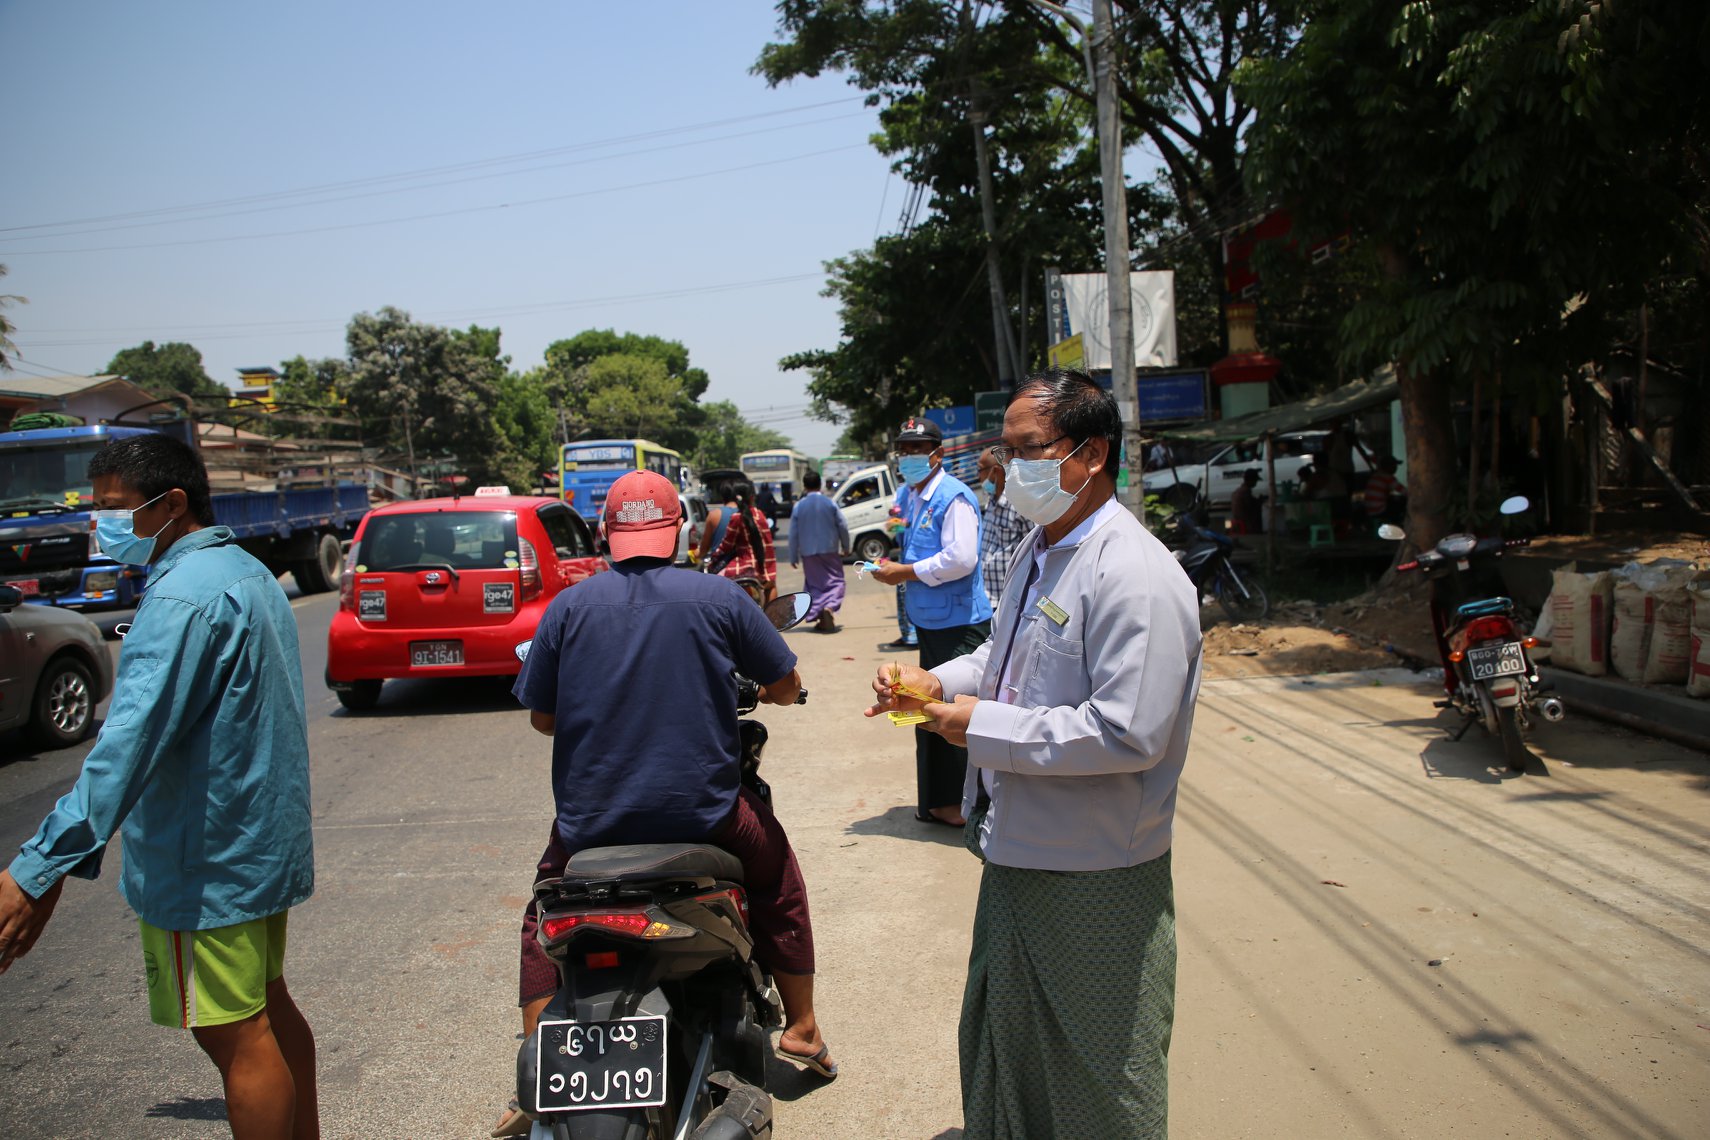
top-left (867, 369), bottom-right (1200, 1140)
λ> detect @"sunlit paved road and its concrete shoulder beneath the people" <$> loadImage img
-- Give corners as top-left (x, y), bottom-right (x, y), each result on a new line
top-left (0, 573), bottom-right (1710, 1138)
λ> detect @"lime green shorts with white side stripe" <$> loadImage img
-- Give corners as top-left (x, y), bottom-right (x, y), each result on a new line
top-left (137, 911), bottom-right (287, 1029)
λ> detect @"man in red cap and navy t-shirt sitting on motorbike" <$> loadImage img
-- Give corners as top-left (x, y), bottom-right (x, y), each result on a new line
top-left (494, 472), bottom-right (836, 1135)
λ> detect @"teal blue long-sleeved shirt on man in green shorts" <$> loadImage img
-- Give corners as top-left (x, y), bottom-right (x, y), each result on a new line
top-left (10, 526), bottom-right (315, 930)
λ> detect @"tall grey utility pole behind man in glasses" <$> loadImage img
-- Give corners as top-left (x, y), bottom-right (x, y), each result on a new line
top-left (1091, 0), bottom-right (1142, 514)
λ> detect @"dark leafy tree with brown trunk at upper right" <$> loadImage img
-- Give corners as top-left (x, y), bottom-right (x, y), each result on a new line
top-left (1248, 0), bottom-right (1710, 545)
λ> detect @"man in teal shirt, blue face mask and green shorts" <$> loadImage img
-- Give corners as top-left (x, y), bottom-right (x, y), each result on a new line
top-left (0, 436), bottom-right (320, 1140)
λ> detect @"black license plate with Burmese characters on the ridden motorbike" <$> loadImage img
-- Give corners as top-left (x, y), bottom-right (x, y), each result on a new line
top-left (535, 1017), bottom-right (665, 1113)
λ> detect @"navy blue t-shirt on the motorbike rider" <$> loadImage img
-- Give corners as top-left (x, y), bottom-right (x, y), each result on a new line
top-left (511, 561), bottom-right (795, 851)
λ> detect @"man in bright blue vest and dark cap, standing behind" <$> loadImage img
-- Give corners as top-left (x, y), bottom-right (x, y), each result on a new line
top-left (872, 419), bottom-right (992, 827)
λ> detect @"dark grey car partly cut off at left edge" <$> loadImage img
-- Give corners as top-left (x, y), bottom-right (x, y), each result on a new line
top-left (0, 586), bottom-right (113, 749)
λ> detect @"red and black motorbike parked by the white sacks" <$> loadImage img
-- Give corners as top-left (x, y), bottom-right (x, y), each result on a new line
top-left (1378, 496), bottom-right (1566, 773)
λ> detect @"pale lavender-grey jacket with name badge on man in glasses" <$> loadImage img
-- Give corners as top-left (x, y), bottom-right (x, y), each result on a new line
top-left (932, 509), bottom-right (1200, 872)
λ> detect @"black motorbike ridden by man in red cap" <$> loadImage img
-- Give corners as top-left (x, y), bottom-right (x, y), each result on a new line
top-left (516, 593), bottom-right (811, 1140)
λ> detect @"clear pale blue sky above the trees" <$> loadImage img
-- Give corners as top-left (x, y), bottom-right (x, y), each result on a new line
top-left (0, 0), bottom-right (905, 455)
